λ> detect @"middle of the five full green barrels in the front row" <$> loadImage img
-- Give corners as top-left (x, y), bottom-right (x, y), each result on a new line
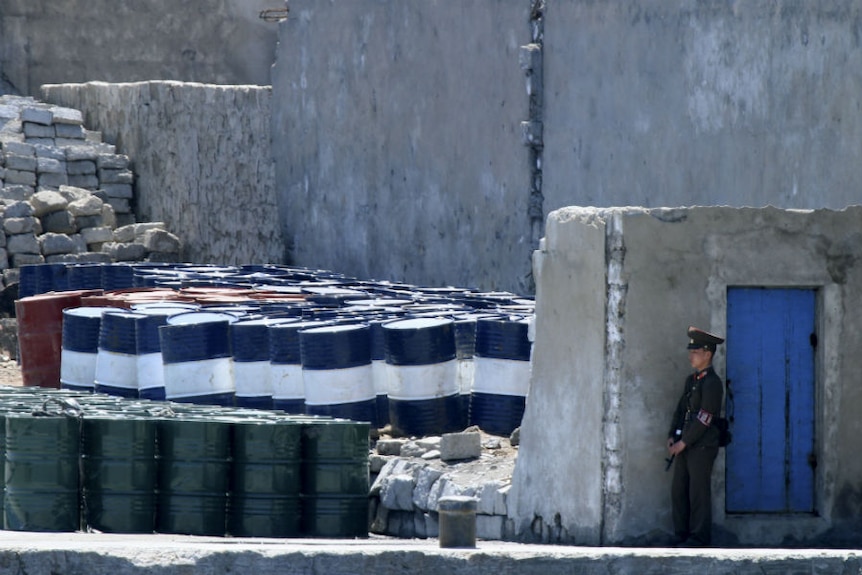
top-left (156, 415), bottom-right (231, 536)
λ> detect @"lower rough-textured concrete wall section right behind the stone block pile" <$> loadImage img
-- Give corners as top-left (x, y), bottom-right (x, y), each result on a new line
top-left (42, 82), bottom-right (284, 264)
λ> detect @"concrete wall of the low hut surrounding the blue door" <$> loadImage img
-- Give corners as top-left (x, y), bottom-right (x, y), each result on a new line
top-left (509, 207), bottom-right (862, 545)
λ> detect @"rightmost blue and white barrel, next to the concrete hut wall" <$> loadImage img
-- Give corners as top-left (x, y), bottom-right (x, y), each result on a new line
top-left (470, 316), bottom-right (531, 435)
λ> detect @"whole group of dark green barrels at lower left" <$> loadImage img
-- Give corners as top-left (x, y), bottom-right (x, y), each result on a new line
top-left (0, 387), bottom-right (369, 538)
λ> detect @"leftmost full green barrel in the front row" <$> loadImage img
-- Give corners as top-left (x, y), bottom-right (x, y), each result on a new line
top-left (3, 413), bottom-right (80, 531)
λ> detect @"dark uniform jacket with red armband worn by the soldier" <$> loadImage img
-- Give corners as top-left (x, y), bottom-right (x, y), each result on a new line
top-left (668, 365), bottom-right (724, 448)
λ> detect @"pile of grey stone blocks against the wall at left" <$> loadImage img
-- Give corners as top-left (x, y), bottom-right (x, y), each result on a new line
top-left (0, 96), bottom-right (180, 290)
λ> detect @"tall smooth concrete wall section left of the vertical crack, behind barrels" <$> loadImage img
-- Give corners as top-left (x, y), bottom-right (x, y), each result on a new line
top-left (272, 0), bottom-right (532, 293)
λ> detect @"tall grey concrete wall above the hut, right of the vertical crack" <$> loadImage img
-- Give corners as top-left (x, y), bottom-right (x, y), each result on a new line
top-left (543, 0), bottom-right (862, 213)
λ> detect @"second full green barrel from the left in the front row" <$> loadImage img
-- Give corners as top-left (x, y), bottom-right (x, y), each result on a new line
top-left (81, 413), bottom-right (156, 533)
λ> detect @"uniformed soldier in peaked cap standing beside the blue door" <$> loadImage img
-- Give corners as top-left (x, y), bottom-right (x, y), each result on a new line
top-left (667, 327), bottom-right (724, 547)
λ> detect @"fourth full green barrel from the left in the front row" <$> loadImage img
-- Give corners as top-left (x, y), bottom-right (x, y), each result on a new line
top-left (227, 419), bottom-right (301, 537)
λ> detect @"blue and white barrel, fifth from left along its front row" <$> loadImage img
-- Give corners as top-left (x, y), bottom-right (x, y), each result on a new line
top-left (230, 317), bottom-right (298, 409)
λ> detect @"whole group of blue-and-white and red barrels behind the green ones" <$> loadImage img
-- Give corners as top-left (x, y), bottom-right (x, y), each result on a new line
top-left (16, 263), bottom-right (534, 436)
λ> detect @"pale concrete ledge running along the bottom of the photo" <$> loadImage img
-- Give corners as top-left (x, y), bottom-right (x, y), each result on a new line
top-left (0, 531), bottom-right (862, 575)
